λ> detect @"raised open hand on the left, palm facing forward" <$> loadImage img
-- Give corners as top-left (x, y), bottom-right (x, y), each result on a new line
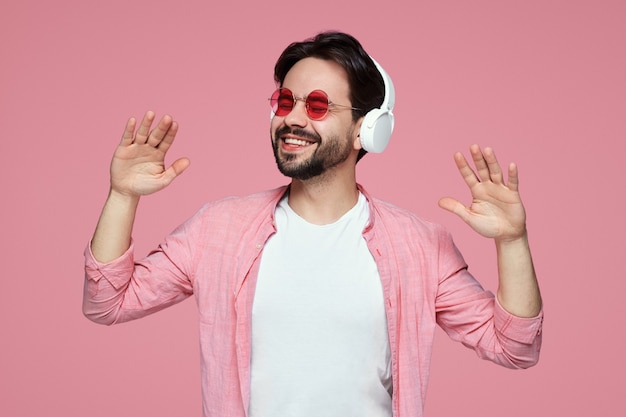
top-left (111, 111), bottom-right (189, 196)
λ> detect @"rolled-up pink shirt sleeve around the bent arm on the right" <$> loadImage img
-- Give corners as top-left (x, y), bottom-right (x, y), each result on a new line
top-left (436, 229), bottom-right (543, 368)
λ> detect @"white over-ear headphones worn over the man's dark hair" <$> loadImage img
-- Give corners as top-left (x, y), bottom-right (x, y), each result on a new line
top-left (359, 57), bottom-right (396, 153)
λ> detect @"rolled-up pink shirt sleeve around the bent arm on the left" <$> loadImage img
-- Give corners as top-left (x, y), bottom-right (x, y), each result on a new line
top-left (83, 231), bottom-right (193, 325)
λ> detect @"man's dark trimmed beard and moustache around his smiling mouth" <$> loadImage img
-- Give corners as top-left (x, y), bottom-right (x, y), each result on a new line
top-left (272, 126), bottom-right (352, 181)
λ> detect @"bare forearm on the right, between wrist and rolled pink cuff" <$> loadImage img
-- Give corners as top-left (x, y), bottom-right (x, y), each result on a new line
top-left (496, 233), bottom-right (541, 317)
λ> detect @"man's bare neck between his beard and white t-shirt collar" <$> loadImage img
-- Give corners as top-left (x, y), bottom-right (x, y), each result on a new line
top-left (289, 170), bottom-right (359, 225)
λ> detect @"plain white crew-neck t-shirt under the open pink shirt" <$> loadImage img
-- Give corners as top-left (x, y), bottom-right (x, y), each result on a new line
top-left (249, 194), bottom-right (392, 417)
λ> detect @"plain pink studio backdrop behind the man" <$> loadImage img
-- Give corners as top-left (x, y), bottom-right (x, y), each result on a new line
top-left (0, 0), bottom-right (626, 417)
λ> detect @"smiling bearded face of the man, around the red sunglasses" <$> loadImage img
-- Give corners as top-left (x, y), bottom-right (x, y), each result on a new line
top-left (271, 58), bottom-right (360, 181)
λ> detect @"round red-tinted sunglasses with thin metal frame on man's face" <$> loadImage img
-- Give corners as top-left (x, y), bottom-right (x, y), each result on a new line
top-left (269, 88), bottom-right (360, 120)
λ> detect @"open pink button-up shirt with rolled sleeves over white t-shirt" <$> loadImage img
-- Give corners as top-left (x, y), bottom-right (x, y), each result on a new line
top-left (83, 187), bottom-right (543, 417)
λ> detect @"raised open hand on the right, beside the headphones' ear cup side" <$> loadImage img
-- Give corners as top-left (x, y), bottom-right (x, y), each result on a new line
top-left (439, 145), bottom-right (526, 241)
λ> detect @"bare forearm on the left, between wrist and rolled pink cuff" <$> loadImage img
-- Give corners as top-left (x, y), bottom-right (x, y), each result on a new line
top-left (91, 190), bottom-right (139, 263)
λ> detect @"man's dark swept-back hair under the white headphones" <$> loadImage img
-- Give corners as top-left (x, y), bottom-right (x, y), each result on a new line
top-left (274, 32), bottom-right (385, 160)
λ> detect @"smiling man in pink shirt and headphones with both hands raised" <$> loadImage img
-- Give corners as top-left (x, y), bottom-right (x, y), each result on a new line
top-left (84, 32), bottom-right (542, 417)
